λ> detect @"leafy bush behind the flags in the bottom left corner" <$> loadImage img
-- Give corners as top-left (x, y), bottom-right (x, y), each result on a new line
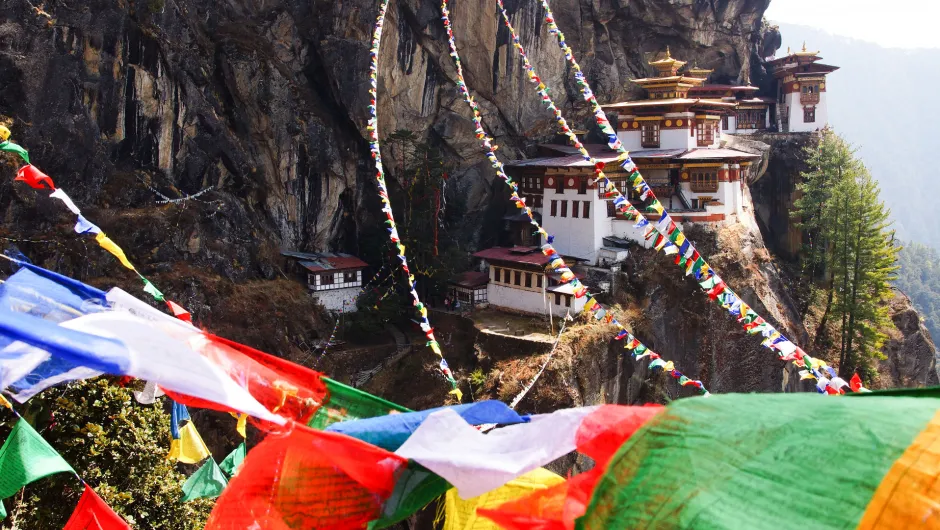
top-left (0, 377), bottom-right (213, 530)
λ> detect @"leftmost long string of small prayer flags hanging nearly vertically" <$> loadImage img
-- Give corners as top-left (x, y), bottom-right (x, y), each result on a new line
top-left (366, 0), bottom-right (463, 401)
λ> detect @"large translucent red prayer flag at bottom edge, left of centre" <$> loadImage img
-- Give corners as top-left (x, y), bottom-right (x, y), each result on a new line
top-left (205, 424), bottom-right (407, 530)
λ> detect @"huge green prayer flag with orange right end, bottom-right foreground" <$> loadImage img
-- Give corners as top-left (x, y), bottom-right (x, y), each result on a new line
top-left (578, 389), bottom-right (940, 530)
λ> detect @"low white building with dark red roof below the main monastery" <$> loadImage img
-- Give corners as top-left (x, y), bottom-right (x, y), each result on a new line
top-left (473, 247), bottom-right (586, 317)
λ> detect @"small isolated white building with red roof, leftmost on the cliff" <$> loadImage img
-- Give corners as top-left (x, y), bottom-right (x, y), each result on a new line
top-left (281, 251), bottom-right (369, 313)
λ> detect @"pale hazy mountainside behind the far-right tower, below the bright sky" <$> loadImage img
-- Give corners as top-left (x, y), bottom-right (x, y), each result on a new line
top-left (771, 21), bottom-right (940, 248)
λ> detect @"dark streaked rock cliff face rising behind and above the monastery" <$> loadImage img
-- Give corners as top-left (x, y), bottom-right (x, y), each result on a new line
top-left (0, 0), bottom-right (769, 280)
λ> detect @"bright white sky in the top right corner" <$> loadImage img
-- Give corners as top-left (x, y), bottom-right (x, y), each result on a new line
top-left (766, 0), bottom-right (940, 48)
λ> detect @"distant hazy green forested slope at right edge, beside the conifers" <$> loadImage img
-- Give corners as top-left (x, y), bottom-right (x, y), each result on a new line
top-left (895, 243), bottom-right (940, 341)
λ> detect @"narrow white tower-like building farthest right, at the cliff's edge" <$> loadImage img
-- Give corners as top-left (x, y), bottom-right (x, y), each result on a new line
top-left (767, 44), bottom-right (839, 132)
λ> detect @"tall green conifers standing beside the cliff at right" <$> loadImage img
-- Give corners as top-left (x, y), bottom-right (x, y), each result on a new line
top-left (795, 131), bottom-right (898, 377)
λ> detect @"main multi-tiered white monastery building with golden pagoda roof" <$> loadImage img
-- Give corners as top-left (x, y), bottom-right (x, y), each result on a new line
top-left (504, 52), bottom-right (768, 264)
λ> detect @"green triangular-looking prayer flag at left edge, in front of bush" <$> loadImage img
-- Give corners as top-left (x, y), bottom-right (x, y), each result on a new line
top-left (0, 418), bottom-right (75, 499)
